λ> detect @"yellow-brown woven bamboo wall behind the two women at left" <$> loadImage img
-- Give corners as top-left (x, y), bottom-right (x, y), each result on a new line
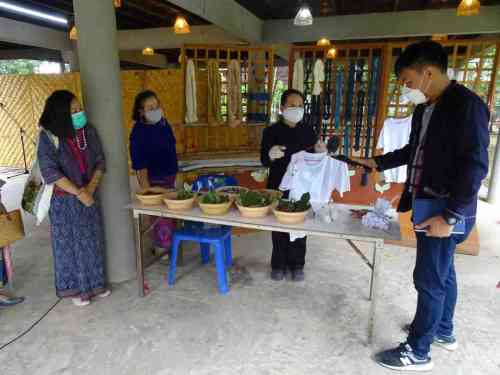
top-left (0, 69), bottom-right (263, 167)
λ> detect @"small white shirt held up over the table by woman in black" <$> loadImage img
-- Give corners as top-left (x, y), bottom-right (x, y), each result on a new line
top-left (279, 151), bottom-right (351, 242)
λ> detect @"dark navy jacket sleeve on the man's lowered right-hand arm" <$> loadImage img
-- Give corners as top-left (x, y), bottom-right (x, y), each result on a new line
top-left (446, 97), bottom-right (490, 219)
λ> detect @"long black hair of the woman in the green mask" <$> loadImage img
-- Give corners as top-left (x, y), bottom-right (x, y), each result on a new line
top-left (40, 90), bottom-right (75, 138)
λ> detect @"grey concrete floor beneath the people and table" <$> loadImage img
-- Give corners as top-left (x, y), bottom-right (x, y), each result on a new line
top-left (0, 174), bottom-right (500, 375)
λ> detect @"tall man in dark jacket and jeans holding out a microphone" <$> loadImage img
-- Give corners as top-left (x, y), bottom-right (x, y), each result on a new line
top-left (362, 41), bottom-right (489, 371)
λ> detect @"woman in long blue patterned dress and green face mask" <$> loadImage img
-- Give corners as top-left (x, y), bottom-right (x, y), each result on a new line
top-left (37, 90), bottom-right (111, 306)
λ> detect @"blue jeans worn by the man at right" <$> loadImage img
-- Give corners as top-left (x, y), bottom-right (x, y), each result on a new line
top-left (407, 219), bottom-right (475, 358)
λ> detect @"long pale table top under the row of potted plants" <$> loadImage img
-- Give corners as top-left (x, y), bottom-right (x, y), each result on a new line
top-left (127, 201), bottom-right (401, 241)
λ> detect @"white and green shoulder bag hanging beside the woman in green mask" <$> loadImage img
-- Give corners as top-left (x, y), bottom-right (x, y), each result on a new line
top-left (21, 130), bottom-right (59, 225)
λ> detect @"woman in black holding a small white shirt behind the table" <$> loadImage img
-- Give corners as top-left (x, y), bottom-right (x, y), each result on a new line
top-left (260, 89), bottom-right (326, 281)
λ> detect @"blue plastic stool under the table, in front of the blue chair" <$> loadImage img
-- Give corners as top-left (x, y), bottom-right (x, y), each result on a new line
top-left (168, 227), bottom-right (233, 294)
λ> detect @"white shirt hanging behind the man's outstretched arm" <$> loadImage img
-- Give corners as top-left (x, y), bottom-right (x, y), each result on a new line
top-left (377, 116), bottom-right (412, 184)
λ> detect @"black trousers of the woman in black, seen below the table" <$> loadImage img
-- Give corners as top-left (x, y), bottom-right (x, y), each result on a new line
top-left (271, 232), bottom-right (306, 270)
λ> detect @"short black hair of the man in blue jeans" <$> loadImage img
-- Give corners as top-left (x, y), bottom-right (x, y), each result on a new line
top-left (395, 40), bottom-right (448, 77)
